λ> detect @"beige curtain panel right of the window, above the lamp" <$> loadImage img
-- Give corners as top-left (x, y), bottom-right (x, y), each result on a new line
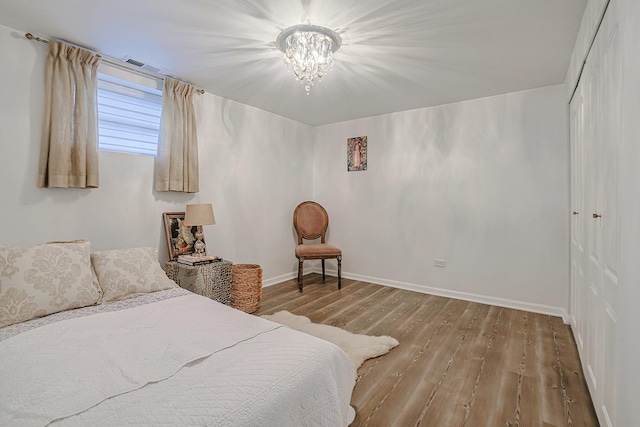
top-left (155, 78), bottom-right (199, 193)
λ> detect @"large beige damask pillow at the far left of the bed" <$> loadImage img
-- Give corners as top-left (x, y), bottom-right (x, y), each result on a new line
top-left (0, 241), bottom-right (101, 327)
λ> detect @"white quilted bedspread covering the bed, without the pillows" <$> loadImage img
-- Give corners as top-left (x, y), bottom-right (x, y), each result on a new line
top-left (0, 295), bottom-right (353, 426)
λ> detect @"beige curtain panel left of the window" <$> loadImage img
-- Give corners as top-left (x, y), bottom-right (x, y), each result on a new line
top-left (38, 40), bottom-right (101, 188)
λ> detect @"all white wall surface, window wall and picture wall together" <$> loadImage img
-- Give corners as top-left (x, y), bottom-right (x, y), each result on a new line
top-left (0, 19), bottom-right (568, 314)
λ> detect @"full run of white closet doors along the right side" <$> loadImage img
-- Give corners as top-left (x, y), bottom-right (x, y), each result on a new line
top-left (570, 0), bottom-right (622, 425)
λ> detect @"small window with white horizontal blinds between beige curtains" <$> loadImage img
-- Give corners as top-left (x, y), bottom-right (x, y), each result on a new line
top-left (98, 72), bottom-right (162, 156)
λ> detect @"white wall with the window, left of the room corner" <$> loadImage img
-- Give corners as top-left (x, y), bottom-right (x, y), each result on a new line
top-left (0, 26), bottom-right (313, 281)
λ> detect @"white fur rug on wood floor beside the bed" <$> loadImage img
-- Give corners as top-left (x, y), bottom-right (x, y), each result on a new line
top-left (261, 310), bottom-right (399, 371)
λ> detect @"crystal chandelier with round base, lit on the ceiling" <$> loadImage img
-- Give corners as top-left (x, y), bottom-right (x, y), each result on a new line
top-left (276, 24), bottom-right (342, 95)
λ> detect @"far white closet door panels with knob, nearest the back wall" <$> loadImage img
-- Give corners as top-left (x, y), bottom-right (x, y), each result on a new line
top-left (570, 55), bottom-right (602, 404)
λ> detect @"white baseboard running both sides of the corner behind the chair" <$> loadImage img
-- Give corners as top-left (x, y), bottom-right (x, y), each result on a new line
top-left (282, 267), bottom-right (571, 325)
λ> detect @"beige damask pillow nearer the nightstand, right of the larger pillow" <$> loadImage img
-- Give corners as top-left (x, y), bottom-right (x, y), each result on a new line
top-left (91, 248), bottom-right (178, 303)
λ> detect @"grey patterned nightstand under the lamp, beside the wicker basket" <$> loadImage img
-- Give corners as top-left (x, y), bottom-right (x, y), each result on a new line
top-left (164, 261), bottom-right (233, 304)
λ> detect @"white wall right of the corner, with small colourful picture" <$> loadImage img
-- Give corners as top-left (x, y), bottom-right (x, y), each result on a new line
top-left (313, 85), bottom-right (569, 315)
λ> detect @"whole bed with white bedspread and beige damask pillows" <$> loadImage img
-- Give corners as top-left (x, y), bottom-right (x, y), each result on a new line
top-left (0, 242), bottom-right (355, 427)
